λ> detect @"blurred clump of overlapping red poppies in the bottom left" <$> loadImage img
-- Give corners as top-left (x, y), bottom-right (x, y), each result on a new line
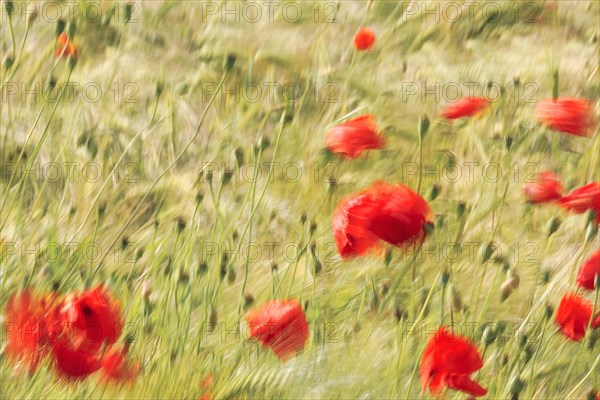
top-left (5, 286), bottom-right (139, 382)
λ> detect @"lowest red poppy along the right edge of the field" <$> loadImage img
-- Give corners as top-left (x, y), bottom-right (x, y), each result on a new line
top-left (555, 293), bottom-right (600, 341)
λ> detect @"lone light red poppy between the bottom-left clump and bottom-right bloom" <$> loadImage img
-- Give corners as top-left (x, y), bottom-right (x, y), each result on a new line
top-left (246, 300), bottom-right (308, 360)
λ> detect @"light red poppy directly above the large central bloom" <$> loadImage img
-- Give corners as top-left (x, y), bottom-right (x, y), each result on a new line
top-left (326, 114), bottom-right (385, 158)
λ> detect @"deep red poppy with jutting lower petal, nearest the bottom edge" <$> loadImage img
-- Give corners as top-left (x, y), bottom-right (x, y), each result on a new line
top-left (420, 327), bottom-right (487, 396)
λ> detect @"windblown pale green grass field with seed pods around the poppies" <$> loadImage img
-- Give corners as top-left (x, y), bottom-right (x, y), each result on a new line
top-left (0, 0), bottom-right (600, 399)
